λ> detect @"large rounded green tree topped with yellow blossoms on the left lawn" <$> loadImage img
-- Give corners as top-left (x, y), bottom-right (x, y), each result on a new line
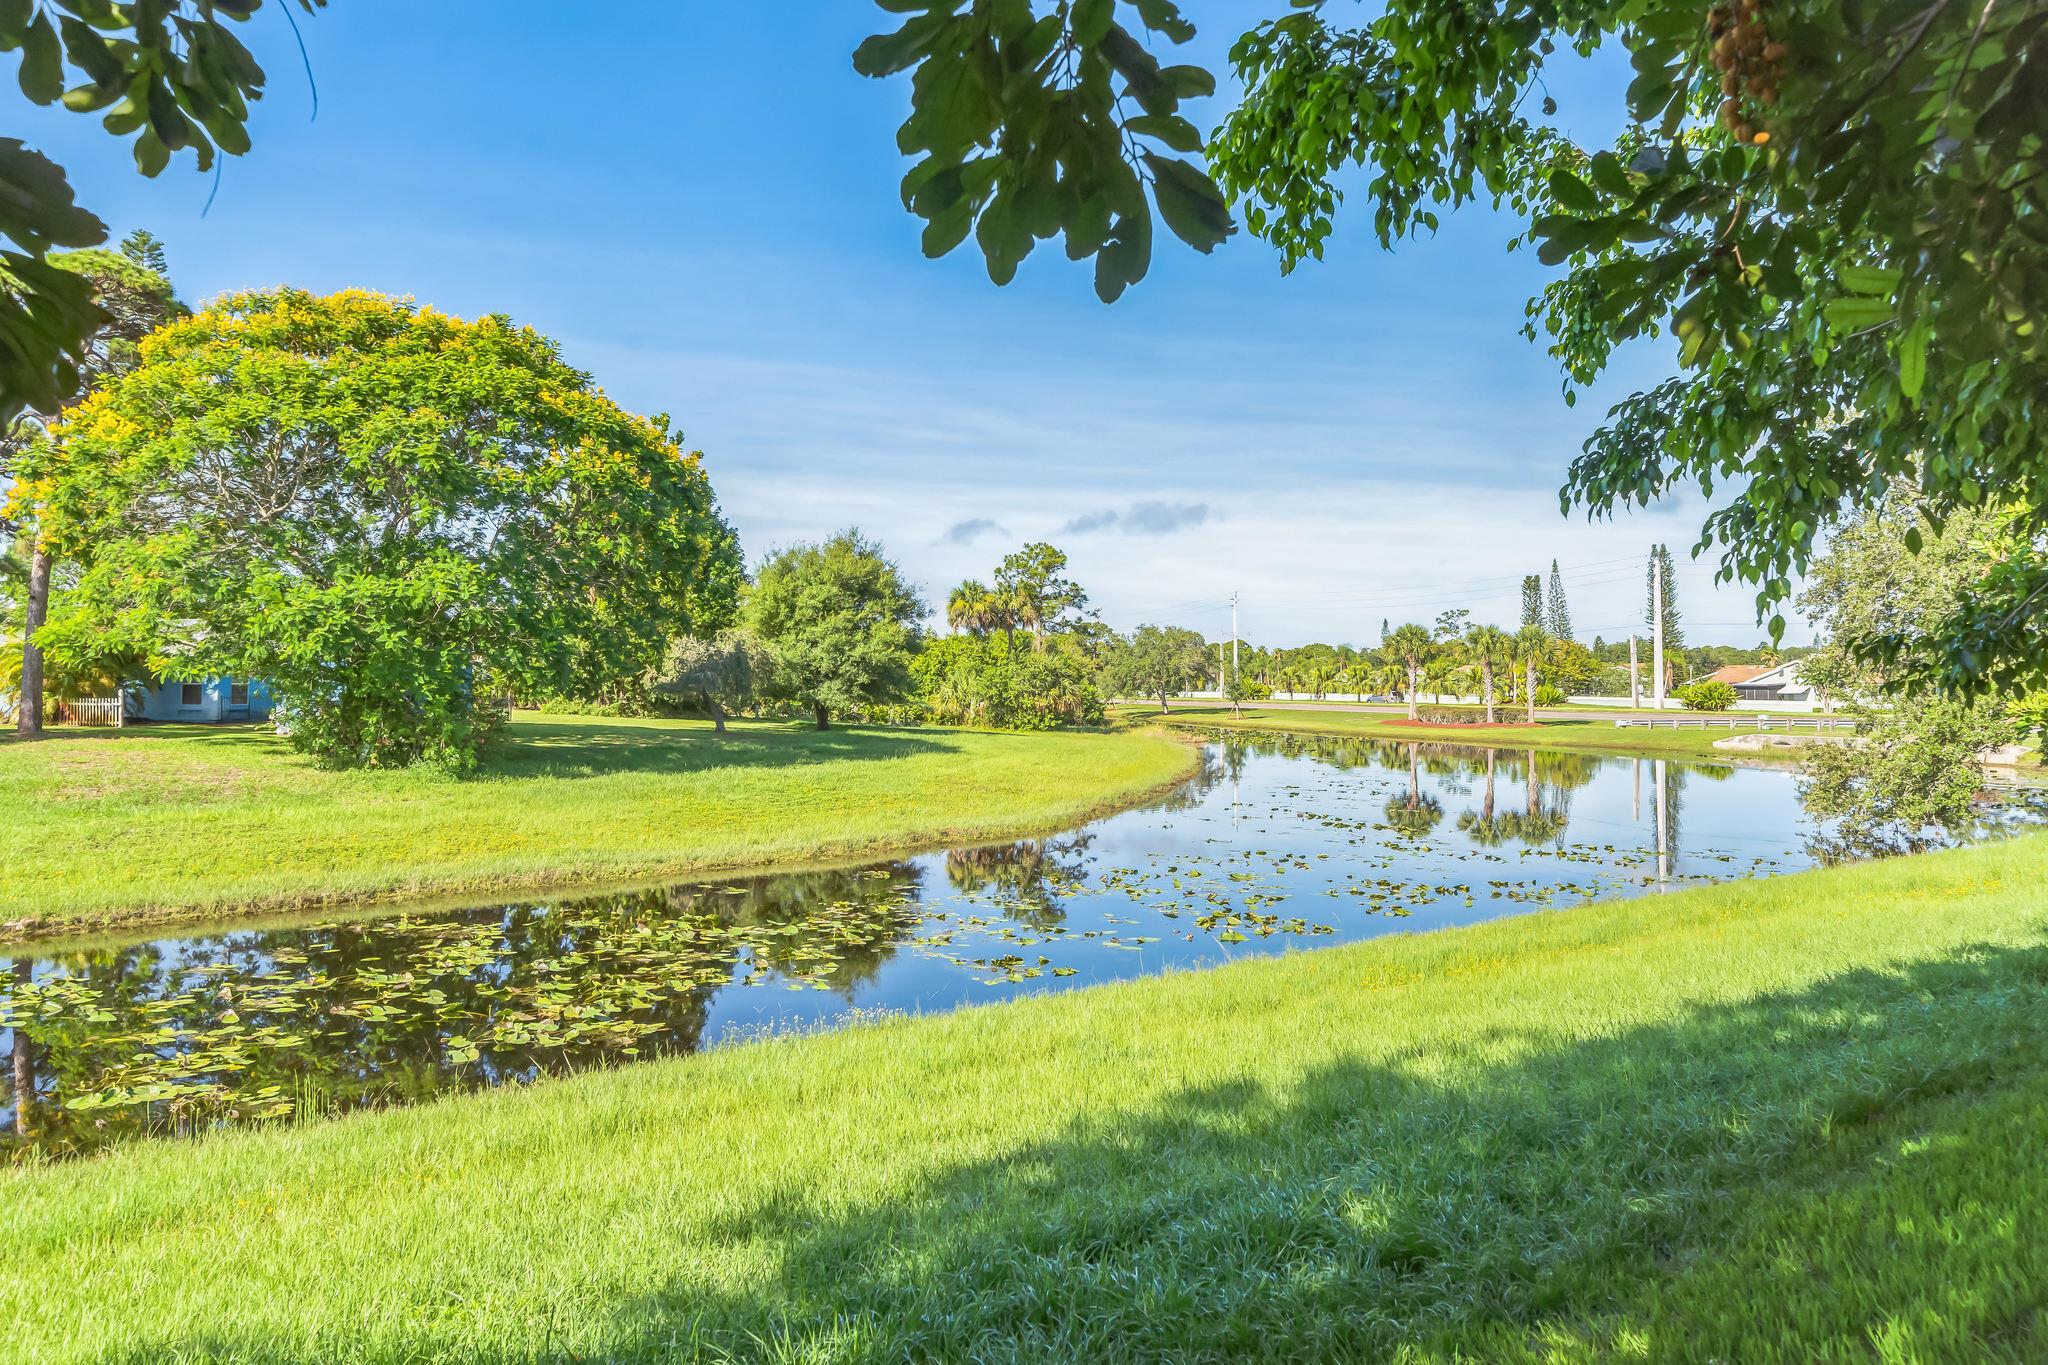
top-left (16, 289), bottom-right (741, 767)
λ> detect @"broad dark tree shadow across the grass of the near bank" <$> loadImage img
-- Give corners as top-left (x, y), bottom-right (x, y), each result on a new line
top-left (103, 945), bottom-right (2048, 1365)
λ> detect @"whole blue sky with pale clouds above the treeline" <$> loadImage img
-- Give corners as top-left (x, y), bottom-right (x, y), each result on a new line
top-left (27, 0), bottom-right (1794, 645)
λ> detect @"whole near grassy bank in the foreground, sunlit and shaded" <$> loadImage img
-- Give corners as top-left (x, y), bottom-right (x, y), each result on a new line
top-left (16, 837), bottom-right (2048, 1365)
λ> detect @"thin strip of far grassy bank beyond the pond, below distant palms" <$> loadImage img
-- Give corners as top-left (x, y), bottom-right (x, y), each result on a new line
top-left (1118, 702), bottom-right (1772, 761)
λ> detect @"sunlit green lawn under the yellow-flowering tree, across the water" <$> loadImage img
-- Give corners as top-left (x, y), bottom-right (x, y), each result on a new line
top-left (0, 716), bottom-right (1194, 933)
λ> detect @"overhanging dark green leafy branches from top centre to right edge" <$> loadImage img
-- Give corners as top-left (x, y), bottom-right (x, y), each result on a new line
top-left (856, 0), bottom-right (2048, 694)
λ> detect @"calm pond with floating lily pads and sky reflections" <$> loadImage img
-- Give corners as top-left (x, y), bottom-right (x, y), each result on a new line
top-left (0, 735), bottom-right (2031, 1160)
